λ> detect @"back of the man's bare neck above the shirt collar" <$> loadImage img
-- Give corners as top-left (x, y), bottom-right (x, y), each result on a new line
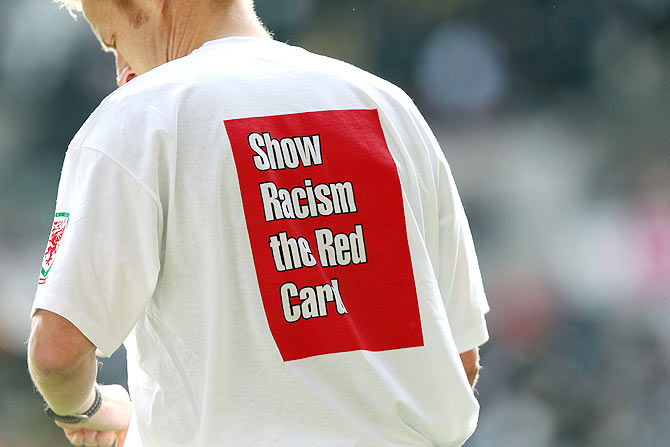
top-left (164, 0), bottom-right (271, 61)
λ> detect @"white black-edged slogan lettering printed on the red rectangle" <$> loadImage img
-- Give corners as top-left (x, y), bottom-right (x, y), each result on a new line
top-left (248, 132), bottom-right (367, 323)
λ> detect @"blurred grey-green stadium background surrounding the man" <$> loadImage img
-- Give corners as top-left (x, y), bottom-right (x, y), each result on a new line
top-left (0, 0), bottom-right (670, 447)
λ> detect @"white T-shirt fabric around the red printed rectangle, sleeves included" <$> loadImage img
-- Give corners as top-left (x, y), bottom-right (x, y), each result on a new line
top-left (33, 38), bottom-right (488, 447)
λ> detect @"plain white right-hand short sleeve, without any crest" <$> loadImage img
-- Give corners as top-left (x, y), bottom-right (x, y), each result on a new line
top-left (437, 154), bottom-right (489, 352)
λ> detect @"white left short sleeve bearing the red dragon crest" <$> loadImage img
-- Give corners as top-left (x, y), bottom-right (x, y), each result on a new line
top-left (32, 148), bottom-right (161, 356)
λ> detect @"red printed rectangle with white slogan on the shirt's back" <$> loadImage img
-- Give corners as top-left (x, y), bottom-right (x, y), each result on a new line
top-left (224, 110), bottom-right (423, 361)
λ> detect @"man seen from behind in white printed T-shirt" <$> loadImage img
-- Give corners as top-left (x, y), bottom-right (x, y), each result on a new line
top-left (28, 0), bottom-right (488, 447)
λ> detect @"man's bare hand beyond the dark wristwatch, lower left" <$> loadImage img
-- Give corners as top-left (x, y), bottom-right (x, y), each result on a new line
top-left (56, 385), bottom-right (133, 447)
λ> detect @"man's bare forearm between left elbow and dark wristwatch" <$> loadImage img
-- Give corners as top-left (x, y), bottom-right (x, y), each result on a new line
top-left (28, 351), bottom-right (98, 415)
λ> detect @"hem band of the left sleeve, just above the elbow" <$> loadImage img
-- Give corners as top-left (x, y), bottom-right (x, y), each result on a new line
top-left (30, 294), bottom-right (123, 357)
